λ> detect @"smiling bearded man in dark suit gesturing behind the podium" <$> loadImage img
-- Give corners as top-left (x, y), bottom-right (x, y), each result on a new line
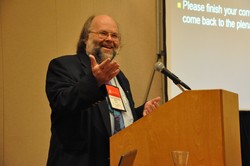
top-left (46, 15), bottom-right (160, 166)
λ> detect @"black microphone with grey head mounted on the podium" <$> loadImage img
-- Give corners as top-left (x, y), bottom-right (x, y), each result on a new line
top-left (155, 62), bottom-right (191, 90)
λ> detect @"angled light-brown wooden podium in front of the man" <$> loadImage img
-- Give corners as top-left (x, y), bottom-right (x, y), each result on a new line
top-left (110, 90), bottom-right (241, 166)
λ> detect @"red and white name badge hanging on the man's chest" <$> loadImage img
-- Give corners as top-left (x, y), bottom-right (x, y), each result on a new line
top-left (106, 85), bottom-right (126, 111)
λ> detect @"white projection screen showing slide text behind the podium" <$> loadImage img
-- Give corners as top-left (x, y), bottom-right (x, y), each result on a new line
top-left (166, 0), bottom-right (250, 110)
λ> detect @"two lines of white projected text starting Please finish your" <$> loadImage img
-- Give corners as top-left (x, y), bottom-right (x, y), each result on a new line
top-left (180, 0), bottom-right (250, 30)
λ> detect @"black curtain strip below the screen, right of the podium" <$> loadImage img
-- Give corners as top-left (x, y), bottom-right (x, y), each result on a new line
top-left (240, 111), bottom-right (250, 166)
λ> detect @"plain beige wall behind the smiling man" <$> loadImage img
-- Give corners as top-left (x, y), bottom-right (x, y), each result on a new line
top-left (0, 0), bottom-right (161, 166)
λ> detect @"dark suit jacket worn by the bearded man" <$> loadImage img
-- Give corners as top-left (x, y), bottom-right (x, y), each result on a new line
top-left (46, 54), bottom-right (143, 166)
